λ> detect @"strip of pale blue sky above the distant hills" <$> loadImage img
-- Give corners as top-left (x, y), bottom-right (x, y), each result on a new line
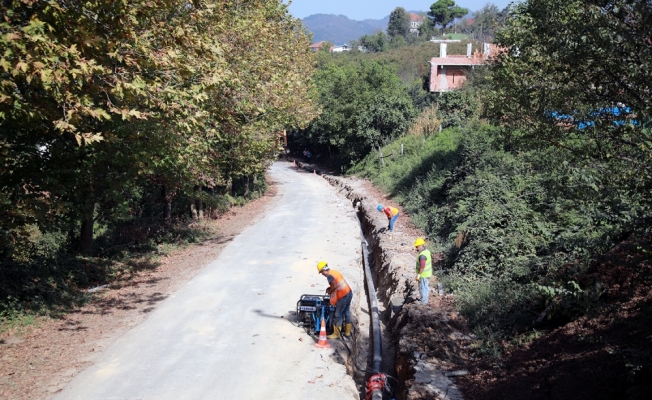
top-left (284, 0), bottom-right (512, 21)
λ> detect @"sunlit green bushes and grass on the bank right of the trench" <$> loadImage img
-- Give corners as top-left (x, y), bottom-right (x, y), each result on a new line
top-left (351, 115), bottom-right (640, 340)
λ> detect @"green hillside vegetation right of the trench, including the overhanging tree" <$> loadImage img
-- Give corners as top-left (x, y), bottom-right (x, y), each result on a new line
top-left (297, 0), bottom-right (652, 390)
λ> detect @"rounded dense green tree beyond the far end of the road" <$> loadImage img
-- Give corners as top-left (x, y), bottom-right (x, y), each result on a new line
top-left (295, 60), bottom-right (416, 168)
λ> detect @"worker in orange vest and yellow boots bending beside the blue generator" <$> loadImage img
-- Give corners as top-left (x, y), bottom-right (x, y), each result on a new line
top-left (317, 261), bottom-right (353, 339)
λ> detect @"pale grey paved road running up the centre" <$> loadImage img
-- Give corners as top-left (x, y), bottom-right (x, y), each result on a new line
top-left (55, 162), bottom-right (362, 400)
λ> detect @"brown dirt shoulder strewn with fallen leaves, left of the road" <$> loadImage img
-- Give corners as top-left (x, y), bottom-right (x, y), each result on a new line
top-left (0, 178), bottom-right (278, 399)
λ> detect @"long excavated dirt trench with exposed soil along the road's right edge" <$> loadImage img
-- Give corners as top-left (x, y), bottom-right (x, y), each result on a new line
top-left (297, 163), bottom-right (475, 400)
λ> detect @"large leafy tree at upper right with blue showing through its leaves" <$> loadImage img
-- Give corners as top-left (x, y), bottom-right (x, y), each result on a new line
top-left (485, 0), bottom-right (652, 232)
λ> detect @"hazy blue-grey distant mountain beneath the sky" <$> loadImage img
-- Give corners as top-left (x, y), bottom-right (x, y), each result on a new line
top-left (302, 14), bottom-right (389, 45)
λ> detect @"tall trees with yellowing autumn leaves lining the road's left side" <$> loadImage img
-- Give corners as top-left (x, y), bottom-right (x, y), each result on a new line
top-left (0, 0), bottom-right (315, 257)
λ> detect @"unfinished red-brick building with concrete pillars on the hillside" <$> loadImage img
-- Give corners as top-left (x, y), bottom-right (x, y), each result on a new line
top-left (430, 43), bottom-right (495, 92)
